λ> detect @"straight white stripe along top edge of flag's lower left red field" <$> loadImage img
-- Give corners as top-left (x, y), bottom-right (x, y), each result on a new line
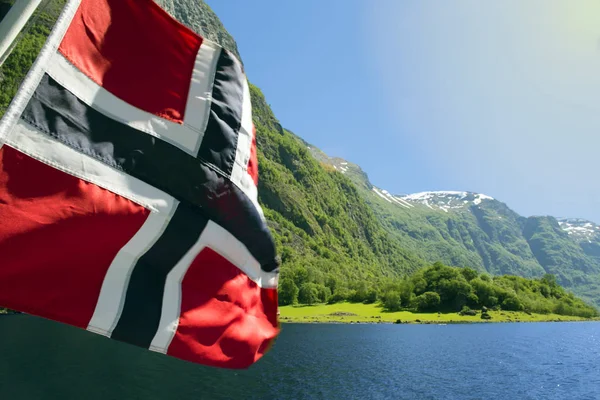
top-left (6, 121), bottom-right (175, 213)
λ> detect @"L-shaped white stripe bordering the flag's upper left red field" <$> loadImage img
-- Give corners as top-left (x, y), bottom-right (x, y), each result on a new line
top-left (47, 45), bottom-right (218, 156)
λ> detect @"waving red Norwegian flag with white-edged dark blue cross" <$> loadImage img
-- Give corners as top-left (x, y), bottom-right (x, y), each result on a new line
top-left (0, 0), bottom-right (279, 368)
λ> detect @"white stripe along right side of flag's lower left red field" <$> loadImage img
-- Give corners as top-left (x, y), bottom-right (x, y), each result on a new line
top-left (87, 201), bottom-right (178, 337)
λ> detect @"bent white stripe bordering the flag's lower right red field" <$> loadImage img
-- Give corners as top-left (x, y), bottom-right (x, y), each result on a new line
top-left (150, 221), bottom-right (278, 353)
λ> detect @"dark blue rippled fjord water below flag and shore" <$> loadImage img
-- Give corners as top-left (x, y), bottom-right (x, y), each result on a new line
top-left (0, 316), bottom-right (600, 400)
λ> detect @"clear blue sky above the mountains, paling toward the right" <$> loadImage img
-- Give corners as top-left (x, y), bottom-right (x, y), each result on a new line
top-left (207, 0), bottom-right (600, 223)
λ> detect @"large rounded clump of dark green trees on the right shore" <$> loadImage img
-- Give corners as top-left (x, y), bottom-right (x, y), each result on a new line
top-left (380, 262), bottom-right (598, 318)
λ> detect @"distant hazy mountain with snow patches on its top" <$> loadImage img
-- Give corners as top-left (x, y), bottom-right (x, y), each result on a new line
top-left (307, 144), bottom-right (600, 302)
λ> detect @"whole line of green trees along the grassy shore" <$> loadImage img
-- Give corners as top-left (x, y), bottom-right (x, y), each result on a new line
top-left (279, 262), bottom-right (598, 318)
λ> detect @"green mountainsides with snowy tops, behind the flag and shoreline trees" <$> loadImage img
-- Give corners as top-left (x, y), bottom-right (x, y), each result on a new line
top-left (0, 0), bottom-right (600, 304)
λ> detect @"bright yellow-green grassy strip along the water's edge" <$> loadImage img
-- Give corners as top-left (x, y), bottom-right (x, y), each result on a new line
top-left (279, 303), bottom-right (600, 324)
